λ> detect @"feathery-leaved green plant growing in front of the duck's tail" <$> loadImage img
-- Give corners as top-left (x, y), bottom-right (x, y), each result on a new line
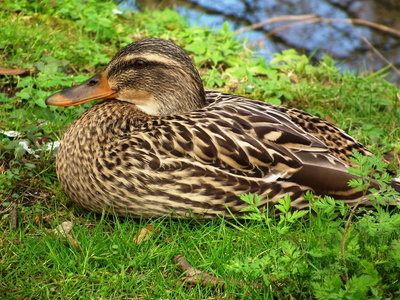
top-left (231, 153), bottom-right (400, 299)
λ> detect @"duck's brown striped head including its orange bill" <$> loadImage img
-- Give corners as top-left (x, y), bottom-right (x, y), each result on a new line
top-left (46, 38), bottom-right (205, 116)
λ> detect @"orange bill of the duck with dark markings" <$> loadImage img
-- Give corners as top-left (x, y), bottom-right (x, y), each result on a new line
top-left (46, 71), bottom-right (118, 106)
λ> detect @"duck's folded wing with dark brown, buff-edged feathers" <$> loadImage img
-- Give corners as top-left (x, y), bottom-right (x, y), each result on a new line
top-left (122, 93), bottom-right (362, 206)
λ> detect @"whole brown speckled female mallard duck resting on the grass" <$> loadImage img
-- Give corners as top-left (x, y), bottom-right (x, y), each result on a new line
top-left (46, 38), bottom-right (396, 218)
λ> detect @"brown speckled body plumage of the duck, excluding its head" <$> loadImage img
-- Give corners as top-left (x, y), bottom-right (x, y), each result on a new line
top-left (57, 92), bottom-right (366, 217)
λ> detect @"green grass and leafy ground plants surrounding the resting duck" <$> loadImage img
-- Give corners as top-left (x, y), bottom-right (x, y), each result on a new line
top-left (0, 0), bottom-right (400, 299)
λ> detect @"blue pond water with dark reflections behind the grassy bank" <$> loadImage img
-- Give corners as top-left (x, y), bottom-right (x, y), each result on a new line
top-left (120, 0), bottom-right (400, 86)
